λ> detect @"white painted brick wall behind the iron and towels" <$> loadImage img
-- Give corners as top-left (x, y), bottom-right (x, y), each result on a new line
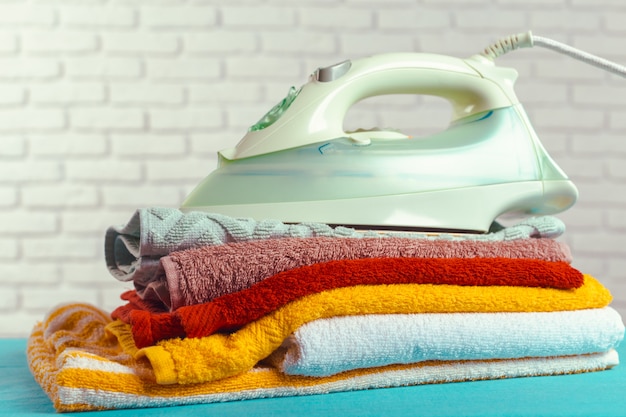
top-left (0, 0), bottom-right (626, 336)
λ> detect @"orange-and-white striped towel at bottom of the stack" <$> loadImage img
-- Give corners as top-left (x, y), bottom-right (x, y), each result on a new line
top-left (27, 304), bottom-right (619, 412)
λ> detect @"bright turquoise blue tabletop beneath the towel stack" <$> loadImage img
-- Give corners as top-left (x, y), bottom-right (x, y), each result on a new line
top-left (0, 339), bottom-right (626, 417)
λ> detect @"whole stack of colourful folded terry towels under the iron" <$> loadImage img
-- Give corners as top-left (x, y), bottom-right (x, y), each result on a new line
top-left (28, 208), bottom-right (624, 411)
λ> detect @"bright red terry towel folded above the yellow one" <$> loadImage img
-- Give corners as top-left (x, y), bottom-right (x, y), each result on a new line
top-left (112, 258), bottom-right (583, 347)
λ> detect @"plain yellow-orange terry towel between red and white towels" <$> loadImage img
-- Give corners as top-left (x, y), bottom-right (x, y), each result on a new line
top-left (109, 275), bottom-right (611, 384)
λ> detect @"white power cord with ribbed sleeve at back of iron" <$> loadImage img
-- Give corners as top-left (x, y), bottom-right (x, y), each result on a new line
top-left (481, 31), bottom-right (626, 77)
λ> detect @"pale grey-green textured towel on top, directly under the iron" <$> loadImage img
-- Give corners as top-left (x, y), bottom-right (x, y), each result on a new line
top-left (104, 207), bottom-right (565, 282)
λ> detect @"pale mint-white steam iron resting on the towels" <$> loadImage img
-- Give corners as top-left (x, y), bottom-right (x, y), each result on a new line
top-left (181, 53), bottom-right (578, 232)
